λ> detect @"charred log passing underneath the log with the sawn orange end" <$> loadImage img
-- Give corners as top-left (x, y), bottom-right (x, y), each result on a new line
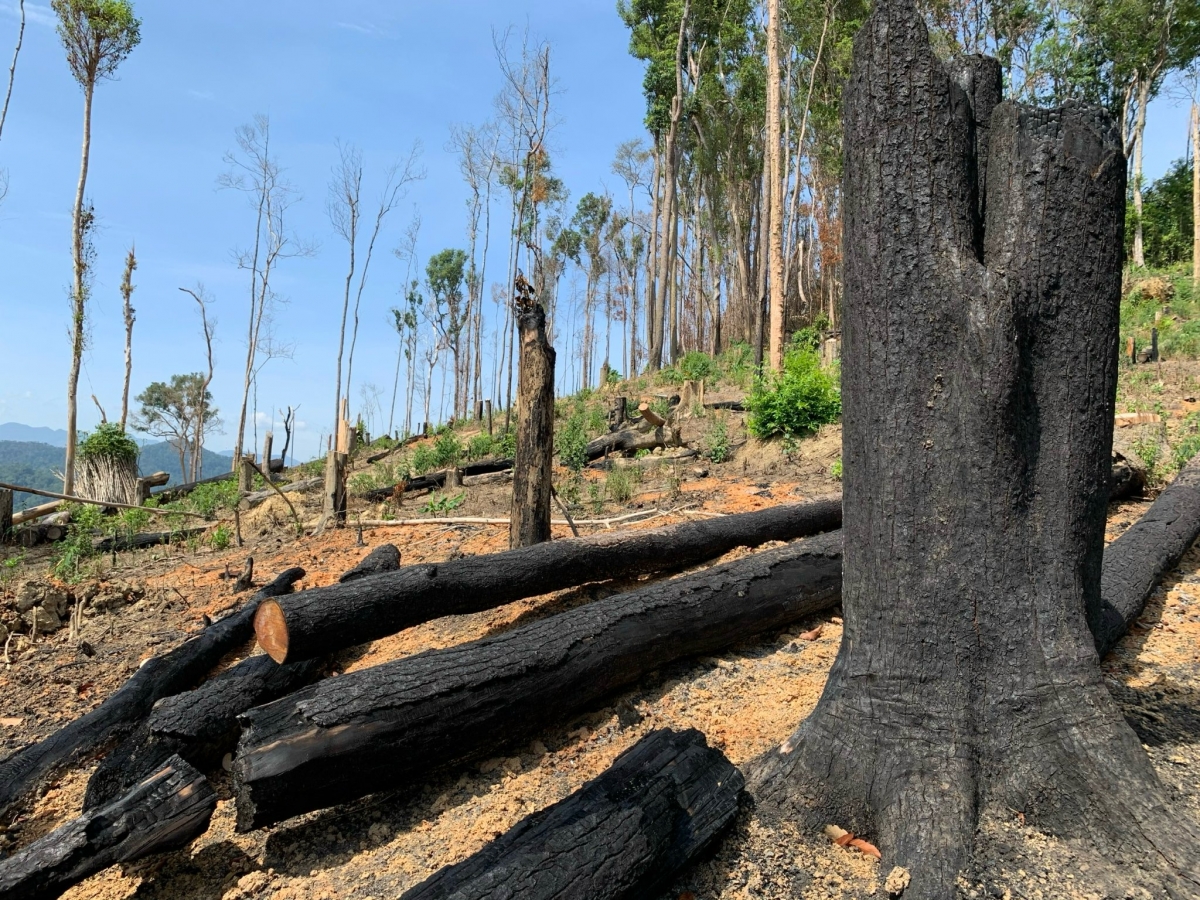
top-left (84, 544), bottom-right (400, 810)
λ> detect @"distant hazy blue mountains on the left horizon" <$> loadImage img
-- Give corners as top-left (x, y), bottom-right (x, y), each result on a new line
top-left (0, 439), bottom-right (229, 510)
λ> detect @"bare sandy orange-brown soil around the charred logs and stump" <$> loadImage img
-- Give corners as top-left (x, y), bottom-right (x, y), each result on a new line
top-left (0, 370), bottom-right (1200, 900)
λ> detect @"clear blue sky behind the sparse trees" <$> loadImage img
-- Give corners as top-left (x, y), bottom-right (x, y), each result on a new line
top-left (0, 0), bottom-right (1187, 465)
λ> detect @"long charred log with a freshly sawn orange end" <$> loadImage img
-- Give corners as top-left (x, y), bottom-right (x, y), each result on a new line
top-left (254, 497), bottom-right (841, 662)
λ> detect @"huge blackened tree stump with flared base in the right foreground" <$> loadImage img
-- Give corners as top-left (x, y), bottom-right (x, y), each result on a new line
top-left (751, 0), bottom-right (1200, 900)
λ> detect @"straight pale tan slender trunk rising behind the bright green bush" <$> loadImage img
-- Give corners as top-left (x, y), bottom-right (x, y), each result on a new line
top-left (763, 0), bottom-right (784, 372)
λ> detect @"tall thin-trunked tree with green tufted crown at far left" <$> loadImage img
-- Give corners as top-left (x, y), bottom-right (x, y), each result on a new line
top-left (50, 0), bottom-right (142, 493)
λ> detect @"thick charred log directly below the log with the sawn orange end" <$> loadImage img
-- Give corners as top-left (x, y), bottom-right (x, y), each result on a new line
top-left (234, 534), bottom-right (841, 830)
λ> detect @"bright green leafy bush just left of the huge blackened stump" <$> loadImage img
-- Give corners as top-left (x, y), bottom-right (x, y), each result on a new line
top-left (746, 346), bottom-right (841, 439)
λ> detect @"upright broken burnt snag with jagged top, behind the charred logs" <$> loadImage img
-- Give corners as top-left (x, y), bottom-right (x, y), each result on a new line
top-left (509, 274), bottom-right (554, 550)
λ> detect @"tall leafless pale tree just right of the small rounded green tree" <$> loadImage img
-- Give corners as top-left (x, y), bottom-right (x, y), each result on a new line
top-left (218, 115), bottom-right (312, 470)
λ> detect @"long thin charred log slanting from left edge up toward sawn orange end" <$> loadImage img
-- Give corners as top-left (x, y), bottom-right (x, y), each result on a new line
top-left (0, 569), bottom-right (305, 817)
